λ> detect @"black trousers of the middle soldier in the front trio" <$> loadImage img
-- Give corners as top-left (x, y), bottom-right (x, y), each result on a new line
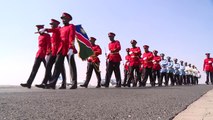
top-left (42, 54), bottom-right (66, 86)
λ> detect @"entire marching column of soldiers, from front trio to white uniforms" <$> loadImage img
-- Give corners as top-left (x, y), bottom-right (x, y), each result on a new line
top-left (21, 13), bottom-right (199, 89)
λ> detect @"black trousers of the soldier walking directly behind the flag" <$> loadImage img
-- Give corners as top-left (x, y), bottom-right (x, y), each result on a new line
top-left (84, 62), bottom-right (101, 86)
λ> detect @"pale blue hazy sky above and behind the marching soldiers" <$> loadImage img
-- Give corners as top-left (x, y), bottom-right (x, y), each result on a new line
top-left (0, 0), bottom-right (213, 85)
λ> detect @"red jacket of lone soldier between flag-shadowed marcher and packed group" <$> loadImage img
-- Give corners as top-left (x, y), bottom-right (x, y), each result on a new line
top-left (107, 40), bottom-right (122, 62)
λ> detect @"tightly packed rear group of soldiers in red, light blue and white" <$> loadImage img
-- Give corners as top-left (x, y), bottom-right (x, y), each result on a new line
top-left (120, 40), bottom-right (201, 87)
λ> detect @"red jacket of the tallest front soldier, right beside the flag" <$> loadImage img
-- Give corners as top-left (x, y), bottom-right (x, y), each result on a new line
top-left (57, 24), bottom-right (77, 56)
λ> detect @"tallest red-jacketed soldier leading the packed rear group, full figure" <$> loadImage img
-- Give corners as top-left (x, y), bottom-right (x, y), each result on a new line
top-left (127, 40), bottom-right (141, 87)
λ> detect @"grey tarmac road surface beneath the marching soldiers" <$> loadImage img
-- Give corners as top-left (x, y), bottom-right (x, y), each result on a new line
top-left (0, 85), bottom-right (213, 120)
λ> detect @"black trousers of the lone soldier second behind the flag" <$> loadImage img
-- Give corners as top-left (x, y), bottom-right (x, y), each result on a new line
top-left (105, 61), bottom-right (121, 87)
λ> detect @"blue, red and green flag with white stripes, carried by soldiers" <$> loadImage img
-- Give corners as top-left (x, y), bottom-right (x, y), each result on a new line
top-left (75, 25), bottom-right (93, 60)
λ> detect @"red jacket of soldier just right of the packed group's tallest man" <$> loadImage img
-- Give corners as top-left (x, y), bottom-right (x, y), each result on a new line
top-left (142, 51), bottom-right (153, 68)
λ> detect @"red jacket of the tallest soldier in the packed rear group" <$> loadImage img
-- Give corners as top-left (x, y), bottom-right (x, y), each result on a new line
top-left (129, 47), bottom-right (141, 66)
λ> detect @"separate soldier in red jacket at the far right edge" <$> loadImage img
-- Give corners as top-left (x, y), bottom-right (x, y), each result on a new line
top-left (203, 53), bottom-right (213, 85)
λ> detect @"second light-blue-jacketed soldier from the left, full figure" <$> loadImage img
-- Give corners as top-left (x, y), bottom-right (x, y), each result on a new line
top-left (167, 56), bottom-right (174, 86)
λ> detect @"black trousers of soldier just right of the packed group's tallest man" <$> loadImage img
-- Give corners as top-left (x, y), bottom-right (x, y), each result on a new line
top-left (142, 68), bottom-right (155, 86)
